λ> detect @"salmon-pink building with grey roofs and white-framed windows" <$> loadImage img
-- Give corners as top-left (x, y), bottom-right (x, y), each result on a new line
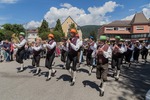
top-left (98, 12), bottom-right (150, 41)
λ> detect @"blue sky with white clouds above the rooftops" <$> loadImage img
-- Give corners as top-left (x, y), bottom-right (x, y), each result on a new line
top-left (0, 0), bottom-right (150, 29)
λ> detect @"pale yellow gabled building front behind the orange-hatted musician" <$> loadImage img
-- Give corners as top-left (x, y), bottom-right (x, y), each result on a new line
top-left (62, 16), bottom-right (82, 39)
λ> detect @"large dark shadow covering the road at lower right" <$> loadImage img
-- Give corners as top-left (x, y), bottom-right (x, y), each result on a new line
top-left (118, 63), bottom-right (150, 100)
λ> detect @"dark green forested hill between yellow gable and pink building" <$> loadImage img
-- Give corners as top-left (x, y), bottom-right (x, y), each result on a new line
top-left (80, 25), bottom-right (101, 38)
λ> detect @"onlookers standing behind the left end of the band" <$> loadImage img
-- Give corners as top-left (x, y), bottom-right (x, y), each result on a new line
top-left (0, 40), bottom-right (60, 62)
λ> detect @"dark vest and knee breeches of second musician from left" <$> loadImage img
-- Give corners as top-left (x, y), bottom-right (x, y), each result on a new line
top-left (32, 46), bottom-right (42, 67)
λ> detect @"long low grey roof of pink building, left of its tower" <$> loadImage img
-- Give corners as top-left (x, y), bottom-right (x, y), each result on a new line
top-left (104, 20), bottom-right (131, 26)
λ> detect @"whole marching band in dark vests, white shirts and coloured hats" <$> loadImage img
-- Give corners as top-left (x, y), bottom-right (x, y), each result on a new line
top-left (2, 29), bottom-right (150, 96)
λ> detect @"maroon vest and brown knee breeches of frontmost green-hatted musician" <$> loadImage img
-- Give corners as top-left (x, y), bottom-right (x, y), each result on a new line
top-left (96, 44), bottom-right (109, 81)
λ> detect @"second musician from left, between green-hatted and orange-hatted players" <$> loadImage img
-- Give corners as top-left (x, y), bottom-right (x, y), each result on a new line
top-left (32, 37), bottom-right (43, 76)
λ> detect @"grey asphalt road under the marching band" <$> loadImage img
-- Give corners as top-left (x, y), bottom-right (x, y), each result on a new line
top-left (0, 57), bottom-right (150, 100)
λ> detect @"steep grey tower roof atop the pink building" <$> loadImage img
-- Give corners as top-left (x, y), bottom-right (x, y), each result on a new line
top-left (130, 12), bottom-right (149, 24)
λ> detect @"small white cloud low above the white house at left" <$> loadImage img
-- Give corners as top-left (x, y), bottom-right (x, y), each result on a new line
top-left (24, 20), bottom-right (41, 29)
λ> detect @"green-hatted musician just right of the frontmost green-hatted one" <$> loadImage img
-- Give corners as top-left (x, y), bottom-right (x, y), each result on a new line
top-left (112, 36), bottom-right (125, 80)
